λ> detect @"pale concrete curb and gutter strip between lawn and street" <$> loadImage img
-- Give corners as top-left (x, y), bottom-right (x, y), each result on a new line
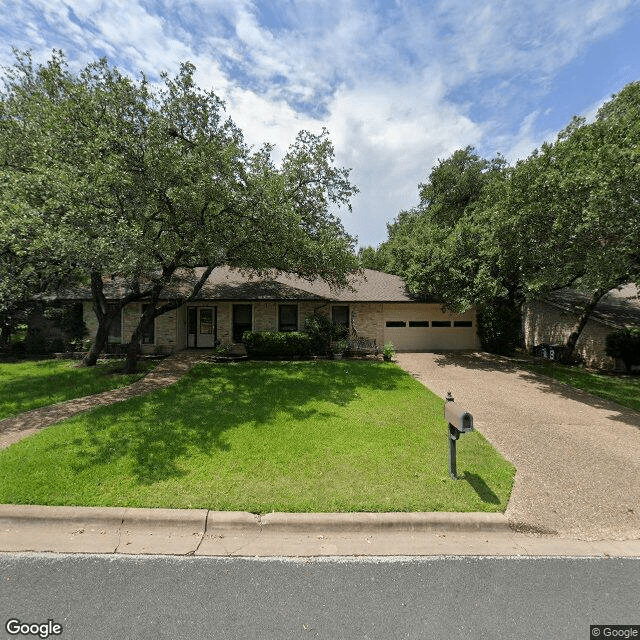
top-left (0, 505), bottom-right (640, 557)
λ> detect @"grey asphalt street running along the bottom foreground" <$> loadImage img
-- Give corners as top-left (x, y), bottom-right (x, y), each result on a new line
top-left (0, 554), bottom-right (640, 640)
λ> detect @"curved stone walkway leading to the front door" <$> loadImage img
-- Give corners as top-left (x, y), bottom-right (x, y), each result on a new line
top-left (0, 351), bottom-right (214, 449)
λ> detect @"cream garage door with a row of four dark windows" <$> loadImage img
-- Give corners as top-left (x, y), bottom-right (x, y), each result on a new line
top-left (383, 303), bottom-right (479, 351)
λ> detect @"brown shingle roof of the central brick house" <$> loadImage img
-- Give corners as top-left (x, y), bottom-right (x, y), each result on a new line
top-left (47, 267), bottom-right (415, 302)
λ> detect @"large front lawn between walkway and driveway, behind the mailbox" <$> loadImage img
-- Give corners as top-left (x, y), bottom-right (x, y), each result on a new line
top-left (0, 361), bottom-right (515, 513)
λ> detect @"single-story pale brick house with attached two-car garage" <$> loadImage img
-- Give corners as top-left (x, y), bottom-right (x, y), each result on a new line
top-left (71, 267), bottom-right (479, 352)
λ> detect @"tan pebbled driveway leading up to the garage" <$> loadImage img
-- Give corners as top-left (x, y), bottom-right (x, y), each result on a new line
top-left (396, 353), bottom-right (640, 540)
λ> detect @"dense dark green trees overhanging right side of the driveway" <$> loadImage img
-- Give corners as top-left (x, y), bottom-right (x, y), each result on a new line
top-left (376, 82), bottom-right (640, 357)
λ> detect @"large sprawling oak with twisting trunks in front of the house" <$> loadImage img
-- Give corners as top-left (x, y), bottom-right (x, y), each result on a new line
top-left (0, 52), bottom-right (357, 364)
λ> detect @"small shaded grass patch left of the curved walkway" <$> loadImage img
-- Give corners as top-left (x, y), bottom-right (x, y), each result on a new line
top-left (0, 360), bottom-right (156, 420)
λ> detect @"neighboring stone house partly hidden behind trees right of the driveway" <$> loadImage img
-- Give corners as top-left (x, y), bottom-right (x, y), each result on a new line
top-left (523, 284), bottom-right (640, 369)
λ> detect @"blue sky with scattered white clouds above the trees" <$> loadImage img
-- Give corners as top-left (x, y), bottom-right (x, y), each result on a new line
top-left (0, 0), bottom-right (640, 246)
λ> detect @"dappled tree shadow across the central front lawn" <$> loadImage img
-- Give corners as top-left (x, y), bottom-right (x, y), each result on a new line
top-left (71, 362), bottom-right (405, 485)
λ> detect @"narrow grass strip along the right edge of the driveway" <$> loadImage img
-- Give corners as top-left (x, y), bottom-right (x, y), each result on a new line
top-left (526, 361), bottom-right (640, 411)
